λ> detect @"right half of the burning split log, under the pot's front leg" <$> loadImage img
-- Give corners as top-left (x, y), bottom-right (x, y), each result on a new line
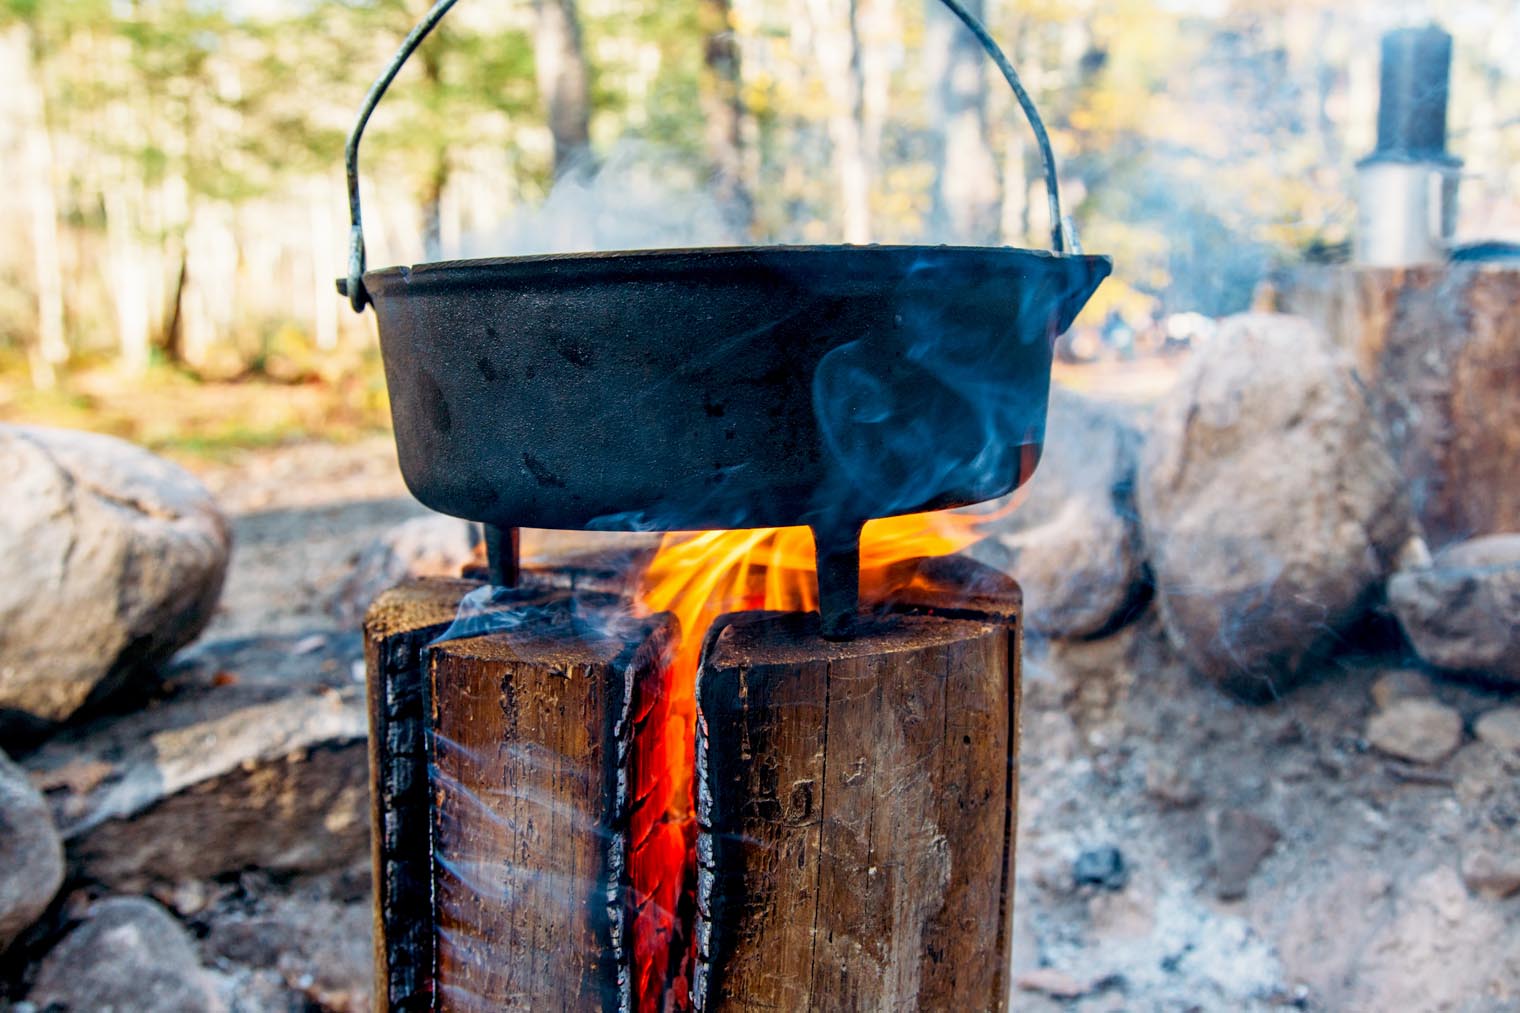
top-left (693, 564), bottom-right (1020, 1011)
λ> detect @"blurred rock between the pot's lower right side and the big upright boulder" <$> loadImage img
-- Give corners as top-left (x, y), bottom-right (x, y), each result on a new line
top-left (973, 386), bottom-right (1143, 637)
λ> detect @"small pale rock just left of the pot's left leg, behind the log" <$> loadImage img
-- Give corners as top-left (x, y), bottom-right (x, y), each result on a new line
top-left (331, 514), bottom-right (476, 627)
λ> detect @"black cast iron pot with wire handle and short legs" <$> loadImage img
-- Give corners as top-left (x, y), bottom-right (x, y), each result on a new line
top-left (339, 0), bottom-right (1111, 633)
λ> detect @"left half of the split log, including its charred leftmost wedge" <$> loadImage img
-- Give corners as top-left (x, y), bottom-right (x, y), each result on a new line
top-left (368, 581), bottom-right (669, 1013)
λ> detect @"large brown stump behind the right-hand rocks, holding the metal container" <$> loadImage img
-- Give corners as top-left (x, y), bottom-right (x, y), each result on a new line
top-left (1283, 265), bottom-right (1520, 548)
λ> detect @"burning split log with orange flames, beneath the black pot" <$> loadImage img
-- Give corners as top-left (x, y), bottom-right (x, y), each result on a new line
top-left (368, 511), bottom-right (1020, 1010)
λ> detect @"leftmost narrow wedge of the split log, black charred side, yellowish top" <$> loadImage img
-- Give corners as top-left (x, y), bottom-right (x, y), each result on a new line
top-left (365, 581), bottom-right (476, 1013)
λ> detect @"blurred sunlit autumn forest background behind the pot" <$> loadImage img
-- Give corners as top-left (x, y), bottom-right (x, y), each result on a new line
top-left (0, 0), bottom-right (1520, 443)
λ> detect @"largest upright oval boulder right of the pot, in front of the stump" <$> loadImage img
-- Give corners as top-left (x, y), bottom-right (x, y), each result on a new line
top-left (1138, 315), bottom-right (1414, 698)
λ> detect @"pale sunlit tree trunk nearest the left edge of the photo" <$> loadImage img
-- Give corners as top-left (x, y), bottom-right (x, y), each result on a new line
top-left (5, 24), bottom-right (68, 388)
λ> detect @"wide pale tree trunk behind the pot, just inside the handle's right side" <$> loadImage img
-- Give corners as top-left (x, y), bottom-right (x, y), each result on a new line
top-left (924, 0), bottom-right (1003, 245)
